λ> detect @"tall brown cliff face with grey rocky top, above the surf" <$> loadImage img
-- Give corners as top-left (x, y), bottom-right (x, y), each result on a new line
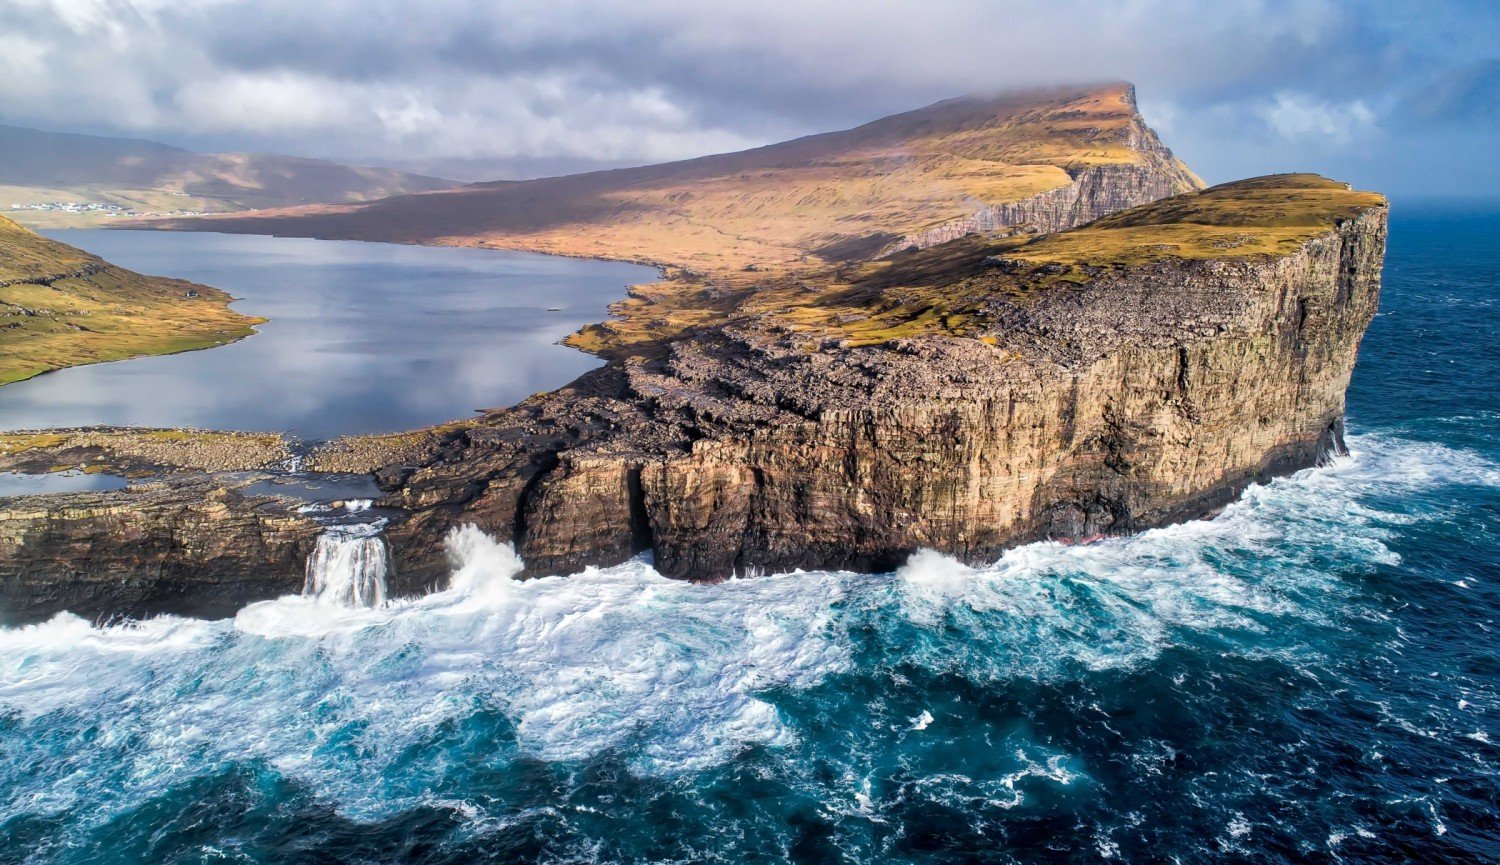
top-left (383, 208), bottom-right (1386, 579)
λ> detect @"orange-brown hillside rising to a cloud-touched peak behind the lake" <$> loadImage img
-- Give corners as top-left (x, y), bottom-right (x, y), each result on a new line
top-left (162, 84), bottom-right (1200, 275)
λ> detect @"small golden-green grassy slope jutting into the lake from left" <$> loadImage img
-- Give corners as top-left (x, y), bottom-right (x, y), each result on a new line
top-left (0, 216), bottom-right (266, 384)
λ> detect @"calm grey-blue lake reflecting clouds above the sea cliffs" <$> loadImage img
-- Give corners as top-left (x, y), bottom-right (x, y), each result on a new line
top-left (0, 229), bottom-right (656, 439)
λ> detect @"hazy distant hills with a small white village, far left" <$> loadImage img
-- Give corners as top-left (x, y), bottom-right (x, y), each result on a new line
top-left (0, 126), bottom-right (453, 226)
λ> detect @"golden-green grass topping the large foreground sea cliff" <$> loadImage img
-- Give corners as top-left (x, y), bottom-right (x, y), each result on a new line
top-left (573, 174), bottom-right (1386, 355)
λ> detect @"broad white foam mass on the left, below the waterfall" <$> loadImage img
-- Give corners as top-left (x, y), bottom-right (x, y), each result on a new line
top-left (0, 528), bottom-right (849, 814)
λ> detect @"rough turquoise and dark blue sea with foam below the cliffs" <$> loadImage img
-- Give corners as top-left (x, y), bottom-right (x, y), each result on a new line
top-left (0, 201), bottom-right (1500, 864)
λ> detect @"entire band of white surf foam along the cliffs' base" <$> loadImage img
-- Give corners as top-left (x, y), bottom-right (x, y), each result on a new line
top-left (0, 436), bottom-right (1500, 820)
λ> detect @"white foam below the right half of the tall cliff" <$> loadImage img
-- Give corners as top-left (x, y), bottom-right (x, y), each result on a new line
top-left (897, 436), bottom-right (1500, 678)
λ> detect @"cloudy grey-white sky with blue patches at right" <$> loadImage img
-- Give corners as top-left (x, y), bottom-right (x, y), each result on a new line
top-left (0, 0), bottom-right (1500, 196)
